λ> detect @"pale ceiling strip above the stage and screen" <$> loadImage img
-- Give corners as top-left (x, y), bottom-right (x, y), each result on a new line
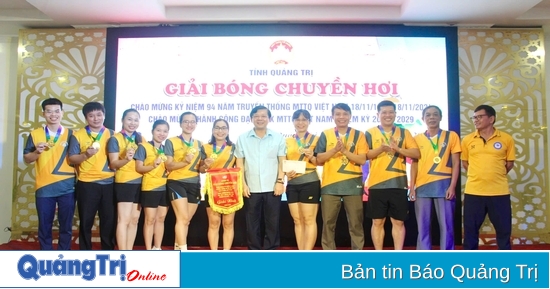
top-left (0, 0), bottom-right (550, 36)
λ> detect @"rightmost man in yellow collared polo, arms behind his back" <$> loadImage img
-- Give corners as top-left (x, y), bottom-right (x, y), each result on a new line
top-left (462, 105), bottom-right (516, 250)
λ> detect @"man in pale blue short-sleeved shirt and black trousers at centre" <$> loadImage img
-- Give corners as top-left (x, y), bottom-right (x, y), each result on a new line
top-left (235, 105), bottom-right (286, 250)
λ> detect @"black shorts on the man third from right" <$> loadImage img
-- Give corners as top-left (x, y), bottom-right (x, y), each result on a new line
top-left (367, 189), bottom-right (409, 221)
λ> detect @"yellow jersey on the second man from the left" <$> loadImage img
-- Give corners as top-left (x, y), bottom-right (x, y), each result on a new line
top-left (69, 128), bottom-right (115, 184)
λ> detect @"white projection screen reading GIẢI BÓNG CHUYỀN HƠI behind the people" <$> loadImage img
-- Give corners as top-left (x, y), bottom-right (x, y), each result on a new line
top-left (105, 24), bottom-right (459, 200)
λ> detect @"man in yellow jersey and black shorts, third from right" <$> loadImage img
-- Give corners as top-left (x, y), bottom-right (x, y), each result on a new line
top-left (365, 100), bottom-right (420, 250)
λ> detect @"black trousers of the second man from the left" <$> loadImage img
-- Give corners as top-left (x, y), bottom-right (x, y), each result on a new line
top-left (75, 181), bottom-right (117, 250)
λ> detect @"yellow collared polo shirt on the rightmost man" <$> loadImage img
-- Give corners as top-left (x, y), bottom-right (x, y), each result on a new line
top-left (462, 129), bottom-right (516, 196)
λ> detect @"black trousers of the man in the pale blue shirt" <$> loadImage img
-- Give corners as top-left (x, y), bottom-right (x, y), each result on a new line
top-left (244, 192), bottom-right (281, 250)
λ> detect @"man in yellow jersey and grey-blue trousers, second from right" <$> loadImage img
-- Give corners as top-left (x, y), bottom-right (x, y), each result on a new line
top-left (409, 105), bottom-right (461, 250)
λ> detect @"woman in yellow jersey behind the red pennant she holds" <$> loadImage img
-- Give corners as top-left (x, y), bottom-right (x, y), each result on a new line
top-left (200, 119), bottom-right (236, 250)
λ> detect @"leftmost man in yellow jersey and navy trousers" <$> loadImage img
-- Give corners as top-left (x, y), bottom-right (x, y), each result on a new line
top-left (23, 98), bottom-right (75, 250)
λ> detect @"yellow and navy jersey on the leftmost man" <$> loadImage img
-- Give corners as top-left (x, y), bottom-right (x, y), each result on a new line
top-left (24, 127), bottom-right (75, 197)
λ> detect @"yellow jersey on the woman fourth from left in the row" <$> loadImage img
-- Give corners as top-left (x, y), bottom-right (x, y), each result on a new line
top-left (134, 142), bottom-right (167, 192)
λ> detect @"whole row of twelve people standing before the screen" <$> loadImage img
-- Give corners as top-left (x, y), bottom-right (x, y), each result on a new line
top-left (24, 98), bottom-right (515, 250)
